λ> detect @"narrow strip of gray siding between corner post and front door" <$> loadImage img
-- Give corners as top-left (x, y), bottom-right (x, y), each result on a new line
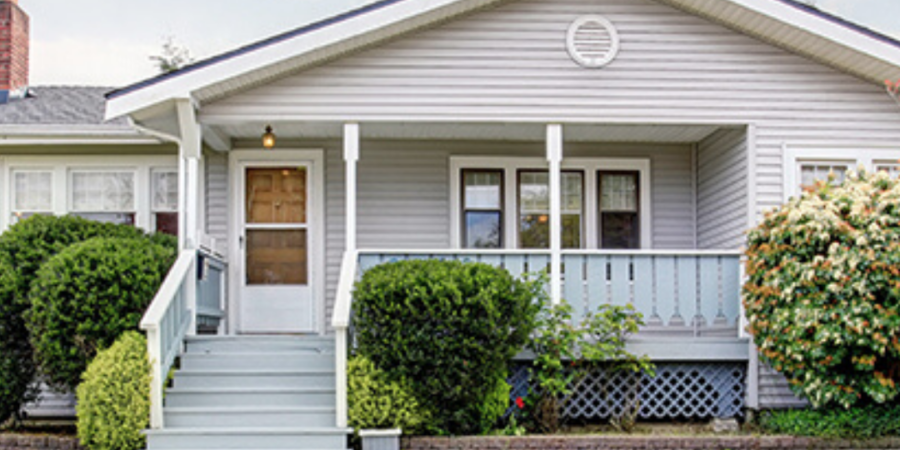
top-left (203, 152), bottom-right (228, 255)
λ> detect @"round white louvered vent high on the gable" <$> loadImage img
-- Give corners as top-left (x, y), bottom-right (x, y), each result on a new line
top-left (566, 16), bottom-right (619, 67)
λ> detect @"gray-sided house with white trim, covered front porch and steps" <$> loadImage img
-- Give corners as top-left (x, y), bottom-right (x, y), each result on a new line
top-left (22, 0), bottom-right (900, 450)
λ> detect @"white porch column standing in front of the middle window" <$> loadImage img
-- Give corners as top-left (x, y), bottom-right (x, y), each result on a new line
top-left (547, 124), bottom-right (563, 305)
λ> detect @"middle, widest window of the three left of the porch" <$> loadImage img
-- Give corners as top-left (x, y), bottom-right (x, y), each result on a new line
top-left (69, 170), bottom-right (136, 225)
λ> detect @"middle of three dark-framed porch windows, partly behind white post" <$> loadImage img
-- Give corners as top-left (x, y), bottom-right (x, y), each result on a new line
top-left (518, 170), bottom-right (584, 248)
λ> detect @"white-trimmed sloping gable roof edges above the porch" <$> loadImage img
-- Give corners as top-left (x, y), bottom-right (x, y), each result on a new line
top-left (106, 0), bottom-right (900, 117)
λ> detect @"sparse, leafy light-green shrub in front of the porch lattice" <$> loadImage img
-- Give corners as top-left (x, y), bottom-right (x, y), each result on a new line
top-left (530, 301), bottom-right (654, 433)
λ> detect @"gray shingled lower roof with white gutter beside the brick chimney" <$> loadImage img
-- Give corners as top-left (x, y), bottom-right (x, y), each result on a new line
top-left (0, 86), bottom-right (159, 145)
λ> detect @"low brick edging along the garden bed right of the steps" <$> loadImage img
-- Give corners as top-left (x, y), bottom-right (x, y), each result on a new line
top-left (400, 436), bottom-right (900, 450)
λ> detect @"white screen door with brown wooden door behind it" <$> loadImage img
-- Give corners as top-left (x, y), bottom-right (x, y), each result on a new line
top-left (240, 166), bottom-right (315, 333)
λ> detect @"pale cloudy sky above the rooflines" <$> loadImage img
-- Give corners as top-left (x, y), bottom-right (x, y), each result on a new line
top-left (19, 0), bottom-right (900, 86)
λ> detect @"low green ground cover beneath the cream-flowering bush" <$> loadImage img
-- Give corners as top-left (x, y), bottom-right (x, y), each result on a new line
top-left (759, 404), bottom-right (900, 439)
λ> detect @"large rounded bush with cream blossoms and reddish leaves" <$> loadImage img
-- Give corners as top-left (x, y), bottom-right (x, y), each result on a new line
top-left (743, 172), bottom-right (900, 408)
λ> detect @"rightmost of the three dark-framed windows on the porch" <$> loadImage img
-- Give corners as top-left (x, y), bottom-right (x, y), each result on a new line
top-left (597, 171), bottom-right (641, 249)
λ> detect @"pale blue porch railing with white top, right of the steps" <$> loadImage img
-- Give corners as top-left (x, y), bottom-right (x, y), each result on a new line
top-left (332, 250), bottom-right (746, 426)
